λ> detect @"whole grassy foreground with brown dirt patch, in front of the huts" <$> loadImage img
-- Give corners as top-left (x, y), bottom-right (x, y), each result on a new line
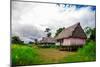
top-left (11, 42), bottom-right (96, 65)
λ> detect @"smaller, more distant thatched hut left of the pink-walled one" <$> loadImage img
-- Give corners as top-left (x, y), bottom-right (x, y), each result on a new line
top-left (40, 37), bottom-right (56, 46)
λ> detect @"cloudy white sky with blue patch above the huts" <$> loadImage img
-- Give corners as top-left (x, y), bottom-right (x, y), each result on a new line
top-left (12, 1), bottom-right (95, 41)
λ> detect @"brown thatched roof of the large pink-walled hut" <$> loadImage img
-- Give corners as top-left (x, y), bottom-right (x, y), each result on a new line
top-left (55, 23), bottom-right (87, 39)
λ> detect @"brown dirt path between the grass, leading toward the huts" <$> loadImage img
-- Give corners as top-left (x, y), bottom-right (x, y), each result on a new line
top-left (39, 48), bottom-right (73, 64)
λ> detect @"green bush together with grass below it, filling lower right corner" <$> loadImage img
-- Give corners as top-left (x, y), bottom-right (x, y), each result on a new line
top-left (63, 41), bottom-right (96, 62)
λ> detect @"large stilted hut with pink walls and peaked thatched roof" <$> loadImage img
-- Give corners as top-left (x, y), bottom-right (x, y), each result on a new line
top-left (55, 23), bottom-right (87, 50)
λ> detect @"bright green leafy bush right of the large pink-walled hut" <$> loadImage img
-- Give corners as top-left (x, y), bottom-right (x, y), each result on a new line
top-left (78, 41), bottom-right (96, 58)
